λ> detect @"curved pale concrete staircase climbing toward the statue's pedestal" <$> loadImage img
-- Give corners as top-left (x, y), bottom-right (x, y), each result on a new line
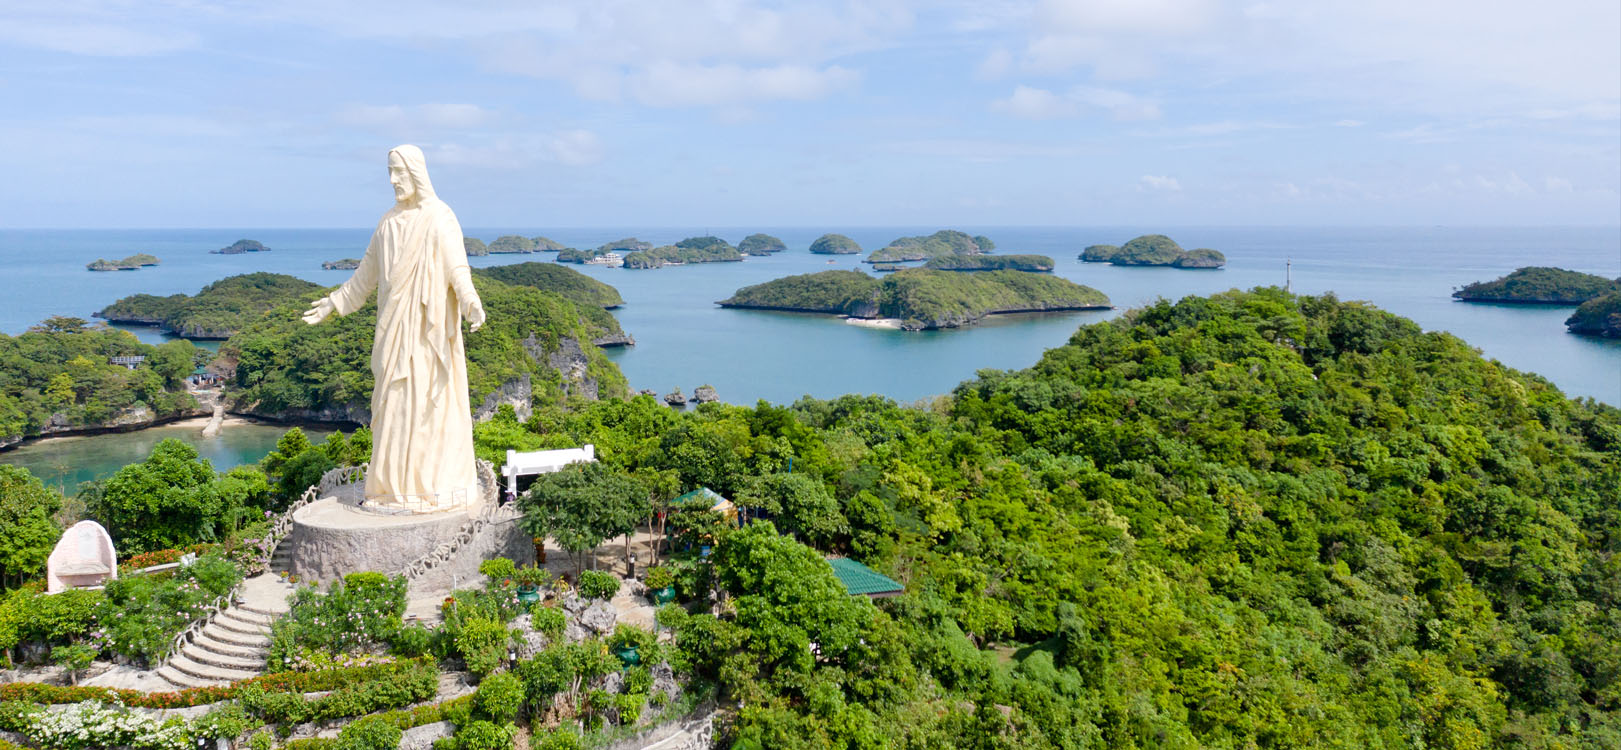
top-left (157, 572), bottom-right (293, 688)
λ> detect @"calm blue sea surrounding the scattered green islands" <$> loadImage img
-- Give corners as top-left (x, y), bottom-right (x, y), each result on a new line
top-left (0, 227), bottom-right (1621, 482)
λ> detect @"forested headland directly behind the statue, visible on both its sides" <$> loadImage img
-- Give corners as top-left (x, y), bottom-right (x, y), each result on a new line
top-left (220, 274), bottom-right (626, 421)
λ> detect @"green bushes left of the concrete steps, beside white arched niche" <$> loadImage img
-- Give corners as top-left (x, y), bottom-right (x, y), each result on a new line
top-left (96, 552), bottom-right (243, 664)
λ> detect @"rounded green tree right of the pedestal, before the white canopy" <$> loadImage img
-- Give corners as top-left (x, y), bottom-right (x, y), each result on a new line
top-left (519, 462), bottom-right (652, 573)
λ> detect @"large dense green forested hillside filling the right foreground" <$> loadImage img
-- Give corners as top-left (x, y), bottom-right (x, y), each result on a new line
top-left (478, 288), bottom-right (1621, 748)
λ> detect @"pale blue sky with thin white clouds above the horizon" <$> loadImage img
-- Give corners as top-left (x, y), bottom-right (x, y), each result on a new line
top-left (0, 0), bottom-right (1621, 227)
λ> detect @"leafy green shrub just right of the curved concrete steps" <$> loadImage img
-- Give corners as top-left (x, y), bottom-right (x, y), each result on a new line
top-left (266, 573), bottom-right (405, 671)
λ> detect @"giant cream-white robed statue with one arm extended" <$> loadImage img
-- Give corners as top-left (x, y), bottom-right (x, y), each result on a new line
top-left (303, 146), bottom-right (485, 512)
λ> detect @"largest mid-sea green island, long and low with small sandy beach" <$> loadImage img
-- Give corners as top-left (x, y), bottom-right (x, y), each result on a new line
top-left (716, 269), bottom-right (1109, 330)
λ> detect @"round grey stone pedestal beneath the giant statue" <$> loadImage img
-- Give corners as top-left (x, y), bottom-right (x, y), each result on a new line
top-left (282, 470), bottom-right (535, 591)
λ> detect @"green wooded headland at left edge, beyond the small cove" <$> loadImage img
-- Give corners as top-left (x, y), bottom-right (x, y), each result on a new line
top-left (0, 317), bottom-right (207, 445)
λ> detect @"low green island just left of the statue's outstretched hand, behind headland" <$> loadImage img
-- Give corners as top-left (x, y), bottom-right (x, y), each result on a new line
top-left (96, 271), bottom-right (321, 339)
